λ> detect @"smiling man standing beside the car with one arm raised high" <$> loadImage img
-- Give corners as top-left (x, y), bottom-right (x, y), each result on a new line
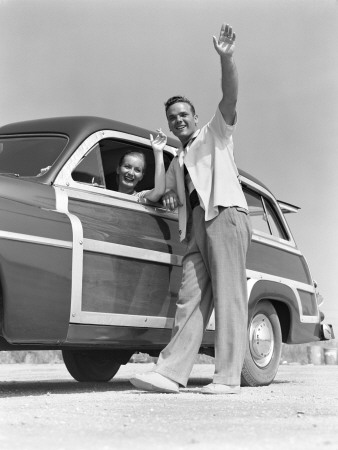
top-left (131, 25), bottom-right (251, 394)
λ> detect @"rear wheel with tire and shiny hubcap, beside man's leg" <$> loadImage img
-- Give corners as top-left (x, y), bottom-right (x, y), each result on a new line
top-left (241, 300), bottom-right (282, 386)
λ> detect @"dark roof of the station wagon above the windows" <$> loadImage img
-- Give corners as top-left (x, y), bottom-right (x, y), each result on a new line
top-left (0, 116), bottom-right (270, 192)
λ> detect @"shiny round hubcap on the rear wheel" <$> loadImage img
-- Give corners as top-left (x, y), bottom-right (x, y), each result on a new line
top-left (249, 314), bottom-right (274, 367)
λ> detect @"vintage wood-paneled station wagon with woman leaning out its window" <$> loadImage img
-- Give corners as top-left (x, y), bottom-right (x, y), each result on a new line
top-left (0, 116), bottom-right (333, 386)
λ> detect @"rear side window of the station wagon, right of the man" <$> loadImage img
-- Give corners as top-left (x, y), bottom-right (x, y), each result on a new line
top-left (243, 187), bottom-right (289, 240)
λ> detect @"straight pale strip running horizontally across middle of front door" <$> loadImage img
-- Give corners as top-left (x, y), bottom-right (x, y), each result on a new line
top-left (84, 238), bottom-right (183, 266)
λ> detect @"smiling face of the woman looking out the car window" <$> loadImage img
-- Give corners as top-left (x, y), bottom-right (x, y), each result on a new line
top-left (116, 155), bottom-right (144, 194)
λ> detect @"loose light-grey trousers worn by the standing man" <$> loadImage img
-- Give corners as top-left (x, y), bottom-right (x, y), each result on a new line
top-left (155, 206), bottom-right (251, 386)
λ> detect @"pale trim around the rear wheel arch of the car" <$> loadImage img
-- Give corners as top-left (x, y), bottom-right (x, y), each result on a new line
top-left (246, 270), bottom-right (320, 323)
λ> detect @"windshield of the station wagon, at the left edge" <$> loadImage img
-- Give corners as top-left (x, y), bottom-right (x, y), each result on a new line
top-left (0, 136), bottom-right (67, 177)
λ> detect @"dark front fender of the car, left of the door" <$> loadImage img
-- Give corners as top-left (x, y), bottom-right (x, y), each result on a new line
top-left (0, 180), bottom-right (73, 343)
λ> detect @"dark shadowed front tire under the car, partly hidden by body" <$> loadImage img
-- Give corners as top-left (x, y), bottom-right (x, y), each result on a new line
top-left (62, 349), bottom-right (133, 382)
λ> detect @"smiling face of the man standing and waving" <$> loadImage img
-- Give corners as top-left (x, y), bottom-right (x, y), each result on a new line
top-left (167, 102), bottom-right (198, 144)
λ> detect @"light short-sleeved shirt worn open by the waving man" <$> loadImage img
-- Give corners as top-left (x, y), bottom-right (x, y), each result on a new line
top-left (166, 108), bottom-right (248, 240)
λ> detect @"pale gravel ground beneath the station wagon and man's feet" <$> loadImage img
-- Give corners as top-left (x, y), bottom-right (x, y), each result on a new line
top-left (0, 364), bottom-right (338, 450)
